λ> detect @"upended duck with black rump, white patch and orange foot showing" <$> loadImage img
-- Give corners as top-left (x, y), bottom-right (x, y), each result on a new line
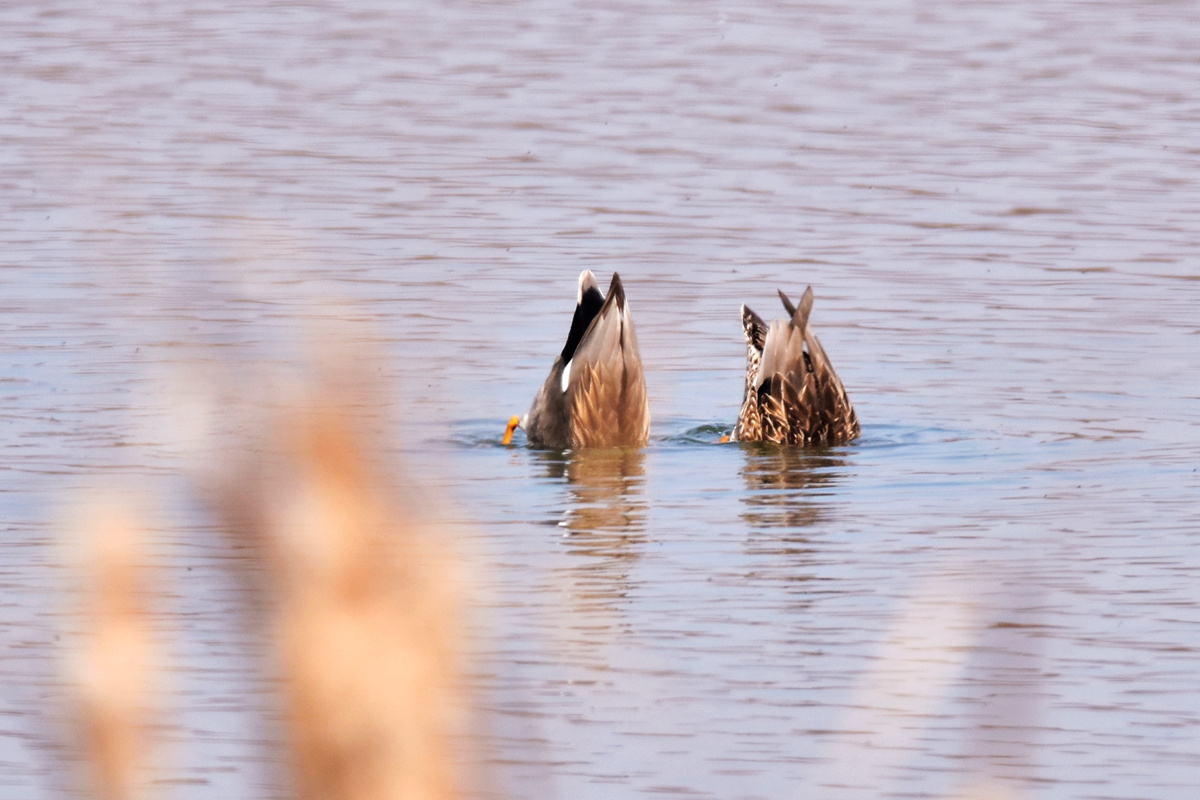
top-left (504, 270), bottom-right (650, 450)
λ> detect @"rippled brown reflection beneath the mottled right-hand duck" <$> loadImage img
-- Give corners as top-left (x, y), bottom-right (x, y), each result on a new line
top-left (742, 443), bottom-right (846, 528)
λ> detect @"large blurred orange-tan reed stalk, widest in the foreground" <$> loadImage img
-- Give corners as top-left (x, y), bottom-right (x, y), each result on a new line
top-left (222, 391), bottom-right (461, 800)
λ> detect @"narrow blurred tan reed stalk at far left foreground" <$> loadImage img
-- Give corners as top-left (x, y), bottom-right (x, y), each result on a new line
top-left (71, 507), bottom-right (160, 800)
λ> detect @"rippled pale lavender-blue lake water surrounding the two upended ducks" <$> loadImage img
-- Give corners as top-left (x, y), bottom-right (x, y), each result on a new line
top-left (0, 0), bottom-right (1200, 800)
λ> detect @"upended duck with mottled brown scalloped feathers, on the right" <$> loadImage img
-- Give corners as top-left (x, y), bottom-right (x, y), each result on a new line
top-left (733, 287), bottom-right (859, 445)
